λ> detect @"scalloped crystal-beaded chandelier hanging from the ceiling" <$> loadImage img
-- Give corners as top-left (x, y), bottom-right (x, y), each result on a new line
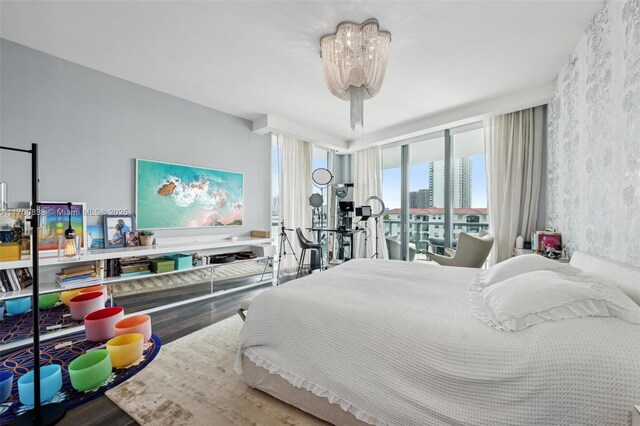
top-left (320, 19), bottom-right (391, 130)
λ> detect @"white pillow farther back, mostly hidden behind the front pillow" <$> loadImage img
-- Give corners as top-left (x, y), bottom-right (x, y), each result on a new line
top-left (473, 254), bottom-right (577, 288)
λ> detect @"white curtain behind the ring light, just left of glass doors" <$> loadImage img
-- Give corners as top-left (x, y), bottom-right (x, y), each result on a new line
top-left (353, 146), bottom-right (389, 259)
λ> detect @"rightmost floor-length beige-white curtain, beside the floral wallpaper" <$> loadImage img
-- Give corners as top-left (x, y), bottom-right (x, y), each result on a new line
top-left (484, 106), bottom-right (546, 264)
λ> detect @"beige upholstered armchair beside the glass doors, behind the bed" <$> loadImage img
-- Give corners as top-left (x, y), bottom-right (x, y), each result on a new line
top-left (427, 230), bottom-right (493, 268)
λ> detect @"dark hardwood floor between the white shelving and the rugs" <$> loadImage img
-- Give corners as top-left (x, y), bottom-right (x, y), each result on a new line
top-left (59, 277), bottom-right (291, 426)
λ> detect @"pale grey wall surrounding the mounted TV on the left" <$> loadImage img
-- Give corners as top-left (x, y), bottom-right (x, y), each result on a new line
top-left (0, 40), bottom-right (271, 235)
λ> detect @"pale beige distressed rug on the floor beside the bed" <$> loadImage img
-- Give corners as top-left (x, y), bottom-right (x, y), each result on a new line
top-left (106, 315), bottom-right (327, 426)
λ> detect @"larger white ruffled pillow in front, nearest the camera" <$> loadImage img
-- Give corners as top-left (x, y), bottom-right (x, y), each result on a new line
top-left (471, 270), bottom-right (640, 331)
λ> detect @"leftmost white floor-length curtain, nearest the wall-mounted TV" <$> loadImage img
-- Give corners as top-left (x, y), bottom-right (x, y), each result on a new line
top-left (278, 135), bottom-right (313, 273)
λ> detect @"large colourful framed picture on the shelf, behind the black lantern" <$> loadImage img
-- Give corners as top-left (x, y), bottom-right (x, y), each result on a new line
top-left (37, 201), bottom-right (87, 253)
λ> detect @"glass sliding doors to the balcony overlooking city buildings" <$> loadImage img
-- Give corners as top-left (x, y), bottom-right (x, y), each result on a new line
top-left (382, 123), bottom-right (489, 261)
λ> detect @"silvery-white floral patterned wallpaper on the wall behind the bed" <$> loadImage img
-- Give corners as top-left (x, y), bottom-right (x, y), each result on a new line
top-left (546, 0), bottom-right (640, 266)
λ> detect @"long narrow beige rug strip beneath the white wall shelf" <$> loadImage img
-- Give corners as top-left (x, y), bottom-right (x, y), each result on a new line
top-left (113, 260), bottom-right (273, 296)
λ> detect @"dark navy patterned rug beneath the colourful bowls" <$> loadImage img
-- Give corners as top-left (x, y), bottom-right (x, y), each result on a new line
top-left (0, 330), bottom-right (162, 425)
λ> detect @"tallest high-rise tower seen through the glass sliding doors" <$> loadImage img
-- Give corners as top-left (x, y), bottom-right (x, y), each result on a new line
top-left (429, 157), bottom-right (473, 208)
